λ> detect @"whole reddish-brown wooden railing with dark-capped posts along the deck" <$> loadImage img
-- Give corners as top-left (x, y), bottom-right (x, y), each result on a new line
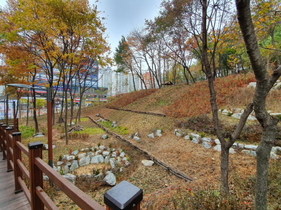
top-left (0, 123), bottom-right (143, 210)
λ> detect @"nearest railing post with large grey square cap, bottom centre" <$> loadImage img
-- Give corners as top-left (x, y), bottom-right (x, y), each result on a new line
top-left (104, 181), bottom-right (143, 210)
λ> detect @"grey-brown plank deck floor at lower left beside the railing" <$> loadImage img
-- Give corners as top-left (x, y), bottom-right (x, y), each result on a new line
top-left (0, 152), bottom-right (31, 210)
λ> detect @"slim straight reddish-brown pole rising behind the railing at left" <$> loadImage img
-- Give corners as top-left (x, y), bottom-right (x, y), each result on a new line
top-left (47, 87), bottom-right (53, 167)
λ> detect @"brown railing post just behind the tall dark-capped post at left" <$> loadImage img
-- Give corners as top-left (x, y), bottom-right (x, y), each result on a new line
top-left (12, 132), bottom-right (22, 193)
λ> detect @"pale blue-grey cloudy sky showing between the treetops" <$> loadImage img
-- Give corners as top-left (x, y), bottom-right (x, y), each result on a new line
top-left (0, 0), bottom-right (162, 55)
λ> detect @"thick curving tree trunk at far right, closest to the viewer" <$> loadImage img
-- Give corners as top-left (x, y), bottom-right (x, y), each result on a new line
top-left (236, 0), bottom-right (281, 210)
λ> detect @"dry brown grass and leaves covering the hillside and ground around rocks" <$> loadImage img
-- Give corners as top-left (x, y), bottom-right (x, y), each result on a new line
top-left (23, 75), bottom-right (281, 209)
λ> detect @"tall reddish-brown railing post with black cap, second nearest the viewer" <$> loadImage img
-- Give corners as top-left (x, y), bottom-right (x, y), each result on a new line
top-left (28, 142), bottom-right (44, 210)
